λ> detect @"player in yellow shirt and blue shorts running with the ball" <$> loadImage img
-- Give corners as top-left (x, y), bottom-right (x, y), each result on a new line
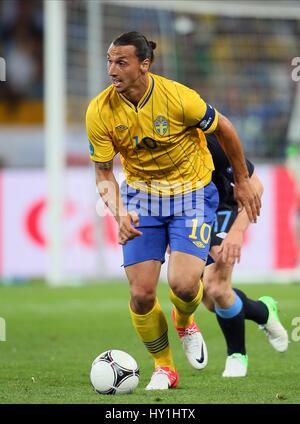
top-left (86, 32), bottom-right (260, 390)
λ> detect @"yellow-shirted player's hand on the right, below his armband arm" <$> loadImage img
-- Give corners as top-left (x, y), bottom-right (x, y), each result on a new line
top-left (234, 179), bottom-right (261, 223)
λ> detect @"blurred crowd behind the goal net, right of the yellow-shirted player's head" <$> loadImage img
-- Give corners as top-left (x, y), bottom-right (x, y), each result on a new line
top-left (104, 5), bottom-right (300, 161)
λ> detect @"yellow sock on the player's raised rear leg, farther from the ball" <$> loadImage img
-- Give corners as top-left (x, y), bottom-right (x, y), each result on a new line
top-left (170, 280), bottom-right (203, 328)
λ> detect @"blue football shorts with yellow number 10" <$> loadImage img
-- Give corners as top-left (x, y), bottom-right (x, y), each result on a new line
top-left (121, 182), bottom-right (219, 267)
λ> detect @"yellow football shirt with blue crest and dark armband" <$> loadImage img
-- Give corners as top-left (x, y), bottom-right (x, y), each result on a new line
top-left (86, 73), bottom-right (218, 194)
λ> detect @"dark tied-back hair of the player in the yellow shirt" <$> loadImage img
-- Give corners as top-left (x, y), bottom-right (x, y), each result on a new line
top-left (113, 31), bottom-right (156, 63)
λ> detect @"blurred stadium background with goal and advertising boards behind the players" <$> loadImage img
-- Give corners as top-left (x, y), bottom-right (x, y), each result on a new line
top-left (0, 0), bottom-right (300, 285)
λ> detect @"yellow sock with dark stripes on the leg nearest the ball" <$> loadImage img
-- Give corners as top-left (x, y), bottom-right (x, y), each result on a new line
top-left (129, 299), bottom-right (175, 371)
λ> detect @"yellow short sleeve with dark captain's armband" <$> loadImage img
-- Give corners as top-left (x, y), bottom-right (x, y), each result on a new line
top-left (183, 87), bottom-right (218, 134)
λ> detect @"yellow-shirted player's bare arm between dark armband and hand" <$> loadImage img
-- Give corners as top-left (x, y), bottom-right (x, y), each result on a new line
top-left (215, 113), bottom-right (249, 182)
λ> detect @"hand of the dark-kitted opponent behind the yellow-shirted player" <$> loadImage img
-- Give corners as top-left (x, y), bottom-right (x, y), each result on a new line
top-left (218, 230), bottom-right (244, 266)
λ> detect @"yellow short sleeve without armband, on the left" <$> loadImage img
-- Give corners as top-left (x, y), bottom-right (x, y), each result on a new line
top-left (86, 98), bottom-right (118, 162)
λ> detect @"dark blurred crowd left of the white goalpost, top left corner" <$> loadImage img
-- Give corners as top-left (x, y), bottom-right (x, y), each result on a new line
top-left (0, 0), bottom-right (43, 103)
